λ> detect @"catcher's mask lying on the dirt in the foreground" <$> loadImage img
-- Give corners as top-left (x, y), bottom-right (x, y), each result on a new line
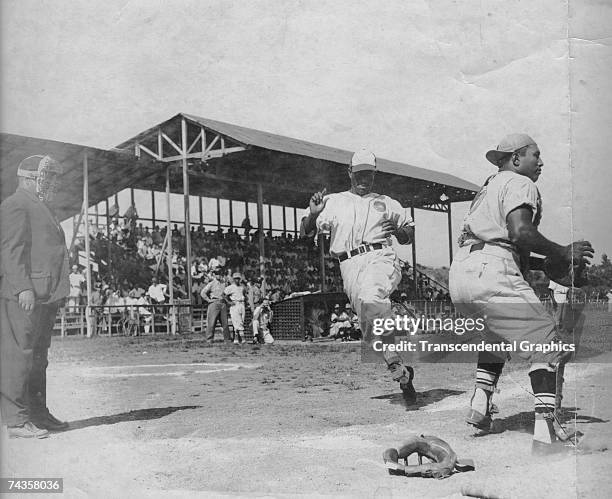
top-left (383, 435), bottom-right (475, 478)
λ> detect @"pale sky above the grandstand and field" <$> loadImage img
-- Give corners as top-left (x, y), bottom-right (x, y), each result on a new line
top-left (0, 0), bottom-right (612, 266)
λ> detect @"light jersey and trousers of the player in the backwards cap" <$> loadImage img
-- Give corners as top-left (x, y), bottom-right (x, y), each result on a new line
top-left (449, 171), bottom-right (562, 365)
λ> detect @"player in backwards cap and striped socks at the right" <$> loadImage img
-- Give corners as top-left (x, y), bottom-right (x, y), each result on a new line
top-left (449, 134), bottom-right (593, 454)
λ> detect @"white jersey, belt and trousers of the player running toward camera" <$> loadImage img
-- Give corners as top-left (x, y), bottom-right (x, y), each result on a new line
top-left (305, 191), bottom-right (412, 362)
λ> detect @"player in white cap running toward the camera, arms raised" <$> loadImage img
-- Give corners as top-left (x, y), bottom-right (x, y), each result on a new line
top-left (301, 149), bottom-right (416, 399)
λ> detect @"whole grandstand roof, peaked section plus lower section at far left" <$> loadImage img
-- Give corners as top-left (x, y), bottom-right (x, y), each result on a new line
top-left (0, 114), bottom-right (478, 219)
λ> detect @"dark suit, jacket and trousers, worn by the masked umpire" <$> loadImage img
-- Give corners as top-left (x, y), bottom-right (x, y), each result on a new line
top-left (0, 188), bottom-right (69, 426)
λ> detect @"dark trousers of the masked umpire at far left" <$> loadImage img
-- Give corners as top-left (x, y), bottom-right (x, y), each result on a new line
top-left (0, 298), bottom-right (58, 426)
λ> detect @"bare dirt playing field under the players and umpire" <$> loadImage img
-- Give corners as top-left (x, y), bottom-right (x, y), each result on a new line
top-left (2, 328), bottom-right (612, 499)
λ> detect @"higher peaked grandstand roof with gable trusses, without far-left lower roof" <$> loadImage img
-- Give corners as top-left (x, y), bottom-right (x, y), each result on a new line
top-left (117, 113), bottom-right (478, 208)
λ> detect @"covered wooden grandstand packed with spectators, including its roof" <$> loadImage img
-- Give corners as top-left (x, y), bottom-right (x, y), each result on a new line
top-left (0, 114), bottom-right (477, 334)
